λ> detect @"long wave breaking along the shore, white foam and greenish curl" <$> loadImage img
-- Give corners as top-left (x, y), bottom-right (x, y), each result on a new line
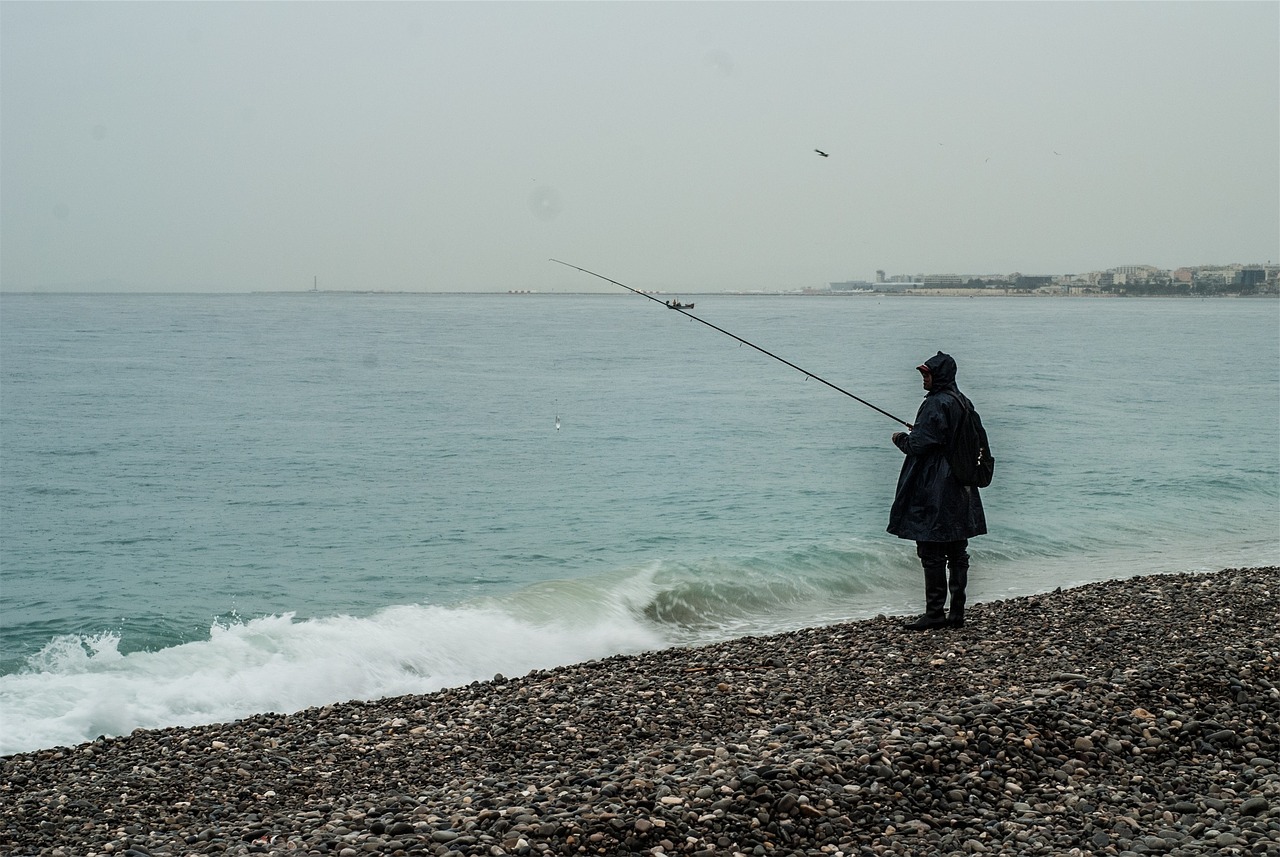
top-left (0, 545), bottom-right (915, 753)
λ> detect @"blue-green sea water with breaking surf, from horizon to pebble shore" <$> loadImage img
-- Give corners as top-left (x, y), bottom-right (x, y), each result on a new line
top-left (0, 293), bottom-right (1280, 753)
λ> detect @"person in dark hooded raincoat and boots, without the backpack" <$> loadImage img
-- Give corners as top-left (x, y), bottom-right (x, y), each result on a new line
top-left (888, 352), bottom-right (987, 631)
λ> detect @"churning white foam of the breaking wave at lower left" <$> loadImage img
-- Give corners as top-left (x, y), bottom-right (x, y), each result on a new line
top-left (0, 606), bottom-right (663, 753)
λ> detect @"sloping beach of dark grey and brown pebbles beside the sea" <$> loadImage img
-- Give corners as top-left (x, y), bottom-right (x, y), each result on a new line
top-left (0, 568), bottom-right (1280, 857)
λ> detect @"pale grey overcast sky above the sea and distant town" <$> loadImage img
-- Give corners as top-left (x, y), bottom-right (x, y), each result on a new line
top-left (0, 1), bottom-right (1280, 292)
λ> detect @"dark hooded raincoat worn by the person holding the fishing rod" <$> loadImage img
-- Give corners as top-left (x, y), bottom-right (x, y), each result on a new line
top-left (888, 352), bottom-right (987, 541)
